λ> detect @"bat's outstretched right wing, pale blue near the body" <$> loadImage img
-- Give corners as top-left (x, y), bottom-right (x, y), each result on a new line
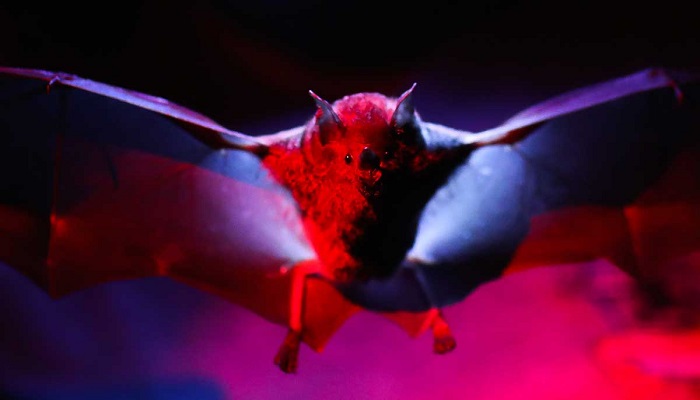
top-left (344, 70), bottom-right (700, 311)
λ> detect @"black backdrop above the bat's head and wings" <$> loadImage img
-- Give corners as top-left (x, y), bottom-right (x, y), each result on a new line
top-left (0, 0), bottom-right (700, 134)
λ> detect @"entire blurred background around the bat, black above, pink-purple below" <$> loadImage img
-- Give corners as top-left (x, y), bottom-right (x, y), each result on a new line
top-left (0, 0), bottom-right (700, 399)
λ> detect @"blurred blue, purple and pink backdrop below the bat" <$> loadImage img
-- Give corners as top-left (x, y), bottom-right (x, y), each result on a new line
top-left (0, 261), bottom-right (700, 400)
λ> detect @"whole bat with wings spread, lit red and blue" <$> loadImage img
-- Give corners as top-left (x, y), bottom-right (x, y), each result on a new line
top-left (0, 67), bottom-right (700, 373)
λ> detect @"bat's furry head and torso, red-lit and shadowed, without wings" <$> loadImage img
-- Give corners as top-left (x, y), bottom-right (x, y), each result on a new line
top-left (265, 88), bottom-right (448, 281)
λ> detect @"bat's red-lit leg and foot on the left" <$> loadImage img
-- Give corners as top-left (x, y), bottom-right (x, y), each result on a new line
top-left (274, 261), bottom-right (318, 374)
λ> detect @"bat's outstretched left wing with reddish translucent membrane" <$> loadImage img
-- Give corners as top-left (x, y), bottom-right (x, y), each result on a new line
top-left (0, 68), bottom-right (356, 347)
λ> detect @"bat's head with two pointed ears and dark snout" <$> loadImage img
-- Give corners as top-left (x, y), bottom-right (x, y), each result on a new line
top-left (308, 84), bottom-right (425, 194)
